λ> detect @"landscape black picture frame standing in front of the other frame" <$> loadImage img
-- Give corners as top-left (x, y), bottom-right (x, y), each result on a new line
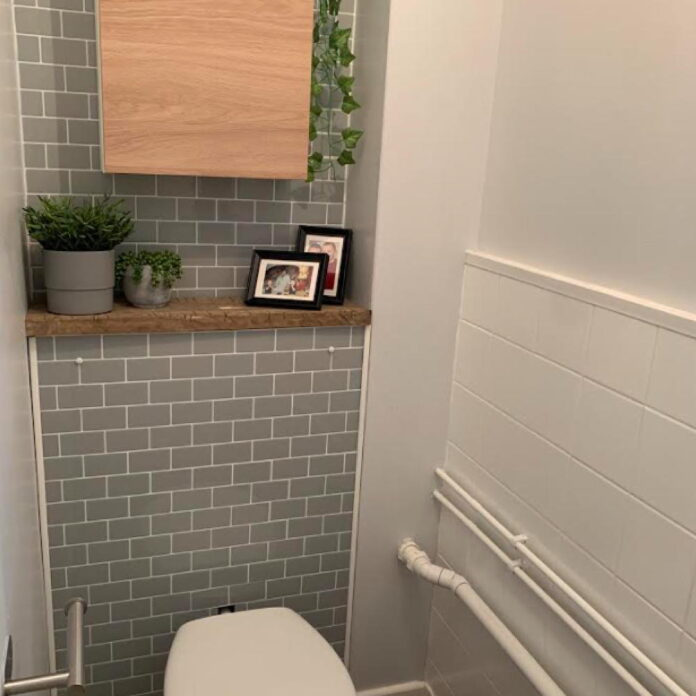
top-left (245, 249), bottom-right (329, 310)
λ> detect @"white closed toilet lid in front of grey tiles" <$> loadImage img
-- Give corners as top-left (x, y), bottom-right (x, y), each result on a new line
top-left (164, 609), bottom-right (355, 696)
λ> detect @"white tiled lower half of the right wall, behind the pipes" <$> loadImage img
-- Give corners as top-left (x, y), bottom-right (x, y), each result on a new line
top-left (428, 266), bottom-right (696, 696)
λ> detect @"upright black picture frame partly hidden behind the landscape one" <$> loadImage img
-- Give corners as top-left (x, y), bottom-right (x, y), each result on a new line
top-left (297, 225), bottom-right (353, 304)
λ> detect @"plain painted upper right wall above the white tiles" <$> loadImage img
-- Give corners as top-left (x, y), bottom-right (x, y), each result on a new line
top-left (478, 0), bottom-right (696, 311)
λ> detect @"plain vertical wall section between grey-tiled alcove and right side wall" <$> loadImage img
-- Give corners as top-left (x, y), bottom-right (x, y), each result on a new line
top-left (347, 0), bottom-right (506, 689)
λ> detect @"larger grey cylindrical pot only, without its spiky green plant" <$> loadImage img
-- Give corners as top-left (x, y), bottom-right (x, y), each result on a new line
top-left (43, 250), bottom-right (115, 314)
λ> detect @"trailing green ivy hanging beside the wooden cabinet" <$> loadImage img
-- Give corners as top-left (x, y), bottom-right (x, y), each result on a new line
top-left (307, 0), bottom-right (363, 181)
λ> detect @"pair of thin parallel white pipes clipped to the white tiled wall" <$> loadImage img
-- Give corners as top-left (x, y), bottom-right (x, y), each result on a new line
top-left (434, 469), bottom-right (690, 696)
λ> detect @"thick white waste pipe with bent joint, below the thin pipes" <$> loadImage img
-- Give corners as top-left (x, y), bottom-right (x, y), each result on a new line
top-left (399, 539), bottom-right (566, 696)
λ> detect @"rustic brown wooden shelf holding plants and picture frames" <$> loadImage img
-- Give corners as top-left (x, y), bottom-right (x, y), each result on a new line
top-left (26, 297), bottom-right (372, 337)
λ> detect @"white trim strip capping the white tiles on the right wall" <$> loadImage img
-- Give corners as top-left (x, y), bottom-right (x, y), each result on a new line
top-left (466, 250), bottom-right (696, 338)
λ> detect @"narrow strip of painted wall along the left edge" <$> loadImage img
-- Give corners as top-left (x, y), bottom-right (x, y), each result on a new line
top-left (0, 0), bottom-right (48, 676)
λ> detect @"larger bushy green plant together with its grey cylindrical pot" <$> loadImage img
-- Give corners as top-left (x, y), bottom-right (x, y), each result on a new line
top-left (23, 196), bottom-right (133, 314)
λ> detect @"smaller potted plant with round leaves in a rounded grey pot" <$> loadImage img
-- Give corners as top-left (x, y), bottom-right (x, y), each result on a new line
top-left (116, 250), bottom-right (182, 309)
